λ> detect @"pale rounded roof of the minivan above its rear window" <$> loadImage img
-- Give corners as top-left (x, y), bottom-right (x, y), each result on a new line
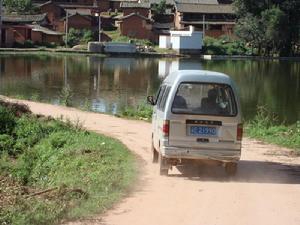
top-left (164, 70), bottom-right (233, 85)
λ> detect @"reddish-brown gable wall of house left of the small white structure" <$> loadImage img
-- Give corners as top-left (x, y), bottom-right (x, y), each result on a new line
top-left (120, 16), bottom-right (153, 40)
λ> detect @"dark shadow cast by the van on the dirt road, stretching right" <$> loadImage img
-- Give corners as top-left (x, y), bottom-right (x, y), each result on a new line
top-left (169, 160), bottom-right (300, 184)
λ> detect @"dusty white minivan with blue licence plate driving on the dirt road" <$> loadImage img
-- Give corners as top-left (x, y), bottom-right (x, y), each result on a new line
top-left (147, 70), bottom-right (243, 175)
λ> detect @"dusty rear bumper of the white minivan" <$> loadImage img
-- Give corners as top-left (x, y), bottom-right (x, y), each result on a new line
top-left (161, 147), bottom-right (241, 162)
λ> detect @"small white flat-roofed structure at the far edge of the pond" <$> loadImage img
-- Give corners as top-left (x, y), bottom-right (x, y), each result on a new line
top-left (159, 26), bottom-right (203, 53)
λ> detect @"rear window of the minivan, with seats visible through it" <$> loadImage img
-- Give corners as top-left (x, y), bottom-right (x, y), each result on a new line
top-left (172, 83), bottom-right (237, 116)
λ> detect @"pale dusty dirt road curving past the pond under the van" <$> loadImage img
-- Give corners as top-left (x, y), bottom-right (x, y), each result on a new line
top-left (4, 98), bottom-right (300, 225)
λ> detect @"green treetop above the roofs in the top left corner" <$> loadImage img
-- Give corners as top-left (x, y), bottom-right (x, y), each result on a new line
top-left (3, 0), bottom-right (33, 13)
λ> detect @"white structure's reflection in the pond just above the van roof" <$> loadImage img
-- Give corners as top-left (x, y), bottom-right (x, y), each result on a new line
top-left (158, 59), bottom-right (202, 77)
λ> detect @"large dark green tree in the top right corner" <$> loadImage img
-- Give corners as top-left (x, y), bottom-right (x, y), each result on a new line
top-left (234, 0), bottom-right (300, 56)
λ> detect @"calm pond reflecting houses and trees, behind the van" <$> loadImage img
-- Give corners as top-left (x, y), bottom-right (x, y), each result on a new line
top-left (0, 55), bottom-right (300, 123)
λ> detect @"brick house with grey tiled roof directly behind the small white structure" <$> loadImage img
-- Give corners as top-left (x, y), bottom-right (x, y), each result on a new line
top-left (175, 0), bottom-right (236, 37)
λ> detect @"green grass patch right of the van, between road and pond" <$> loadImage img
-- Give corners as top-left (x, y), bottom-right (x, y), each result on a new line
top-left (246, 107), bottom-right (300, 154)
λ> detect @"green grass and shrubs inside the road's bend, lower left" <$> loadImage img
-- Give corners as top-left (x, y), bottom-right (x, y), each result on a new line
top-left (0, 101), bottom-right (135, 225)
